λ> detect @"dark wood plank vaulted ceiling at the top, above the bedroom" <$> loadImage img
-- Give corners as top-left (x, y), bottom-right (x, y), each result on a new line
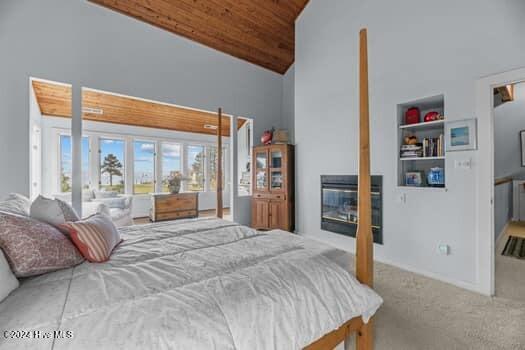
top-left (90, 0), bottom-right (308, 74)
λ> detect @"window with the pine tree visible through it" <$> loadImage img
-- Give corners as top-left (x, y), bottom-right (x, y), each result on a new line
top-left (100, 139), bottom-right (125, 193)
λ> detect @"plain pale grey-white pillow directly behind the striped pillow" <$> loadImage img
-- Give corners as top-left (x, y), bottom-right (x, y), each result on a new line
top-left (30, 196), bottom-right (80, 228)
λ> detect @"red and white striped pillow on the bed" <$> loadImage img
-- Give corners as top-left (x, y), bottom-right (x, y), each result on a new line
top-left (61, 213), bottom-right (122, 263)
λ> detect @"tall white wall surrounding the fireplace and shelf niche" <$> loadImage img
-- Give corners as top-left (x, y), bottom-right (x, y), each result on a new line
top-left (295, 0), bottom-right (525, 289)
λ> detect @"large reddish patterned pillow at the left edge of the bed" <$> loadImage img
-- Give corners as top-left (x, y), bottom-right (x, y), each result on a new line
top-left (0, 212), bottom-right (84, 277)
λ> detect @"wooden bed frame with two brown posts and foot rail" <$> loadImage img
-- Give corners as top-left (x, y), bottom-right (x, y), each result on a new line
top-left (216, 29), bottom-right (374, 350)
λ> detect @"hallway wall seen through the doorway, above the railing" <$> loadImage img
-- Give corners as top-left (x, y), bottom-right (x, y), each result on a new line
top-left (494, 83), bottom-right (525, 179)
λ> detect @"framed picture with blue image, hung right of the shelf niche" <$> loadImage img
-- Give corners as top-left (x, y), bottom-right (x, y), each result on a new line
top-left (445, 119), bottom-right (478, 151)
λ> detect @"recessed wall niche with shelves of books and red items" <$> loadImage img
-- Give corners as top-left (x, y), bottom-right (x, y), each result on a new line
top-left (397, 95), bottom-right (446, 188)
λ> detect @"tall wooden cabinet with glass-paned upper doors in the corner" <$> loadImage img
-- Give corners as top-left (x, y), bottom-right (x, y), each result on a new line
top-left (252, 145), bottom-right (294, 232)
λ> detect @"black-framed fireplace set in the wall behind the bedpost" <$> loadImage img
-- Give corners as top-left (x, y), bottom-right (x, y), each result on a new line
top-left (321, 175), bottom-right (383, 244)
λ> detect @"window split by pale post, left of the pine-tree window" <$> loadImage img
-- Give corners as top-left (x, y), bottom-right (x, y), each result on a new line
top-left (59, 135), bottom-right (90, 192)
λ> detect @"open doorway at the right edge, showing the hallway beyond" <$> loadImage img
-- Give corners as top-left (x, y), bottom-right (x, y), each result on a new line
top-left (493, 82), bottom-right (525, 301)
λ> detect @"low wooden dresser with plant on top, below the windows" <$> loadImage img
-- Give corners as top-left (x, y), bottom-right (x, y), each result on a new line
top-left (150, 192), bottom-right (199, 222)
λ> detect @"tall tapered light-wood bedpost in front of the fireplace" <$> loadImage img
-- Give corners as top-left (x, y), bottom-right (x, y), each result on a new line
top-left (356, 29), bottom-right (374, 350)
